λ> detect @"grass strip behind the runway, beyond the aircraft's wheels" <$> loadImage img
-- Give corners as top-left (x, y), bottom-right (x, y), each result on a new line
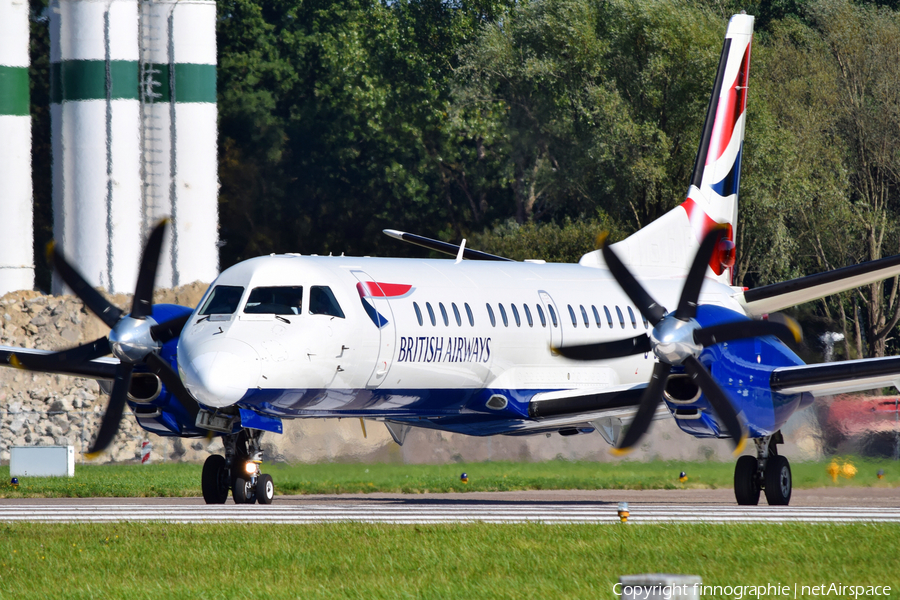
top-left (0, 457), bottom-right (900, 498)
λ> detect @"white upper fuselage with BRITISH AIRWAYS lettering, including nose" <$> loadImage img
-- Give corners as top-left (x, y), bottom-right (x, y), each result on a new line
top-left (178, 255), bottom-right (743, 410)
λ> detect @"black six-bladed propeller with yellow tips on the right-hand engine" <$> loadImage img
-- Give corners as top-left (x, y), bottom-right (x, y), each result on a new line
top-left (554, 226), bottom-right (801, 454)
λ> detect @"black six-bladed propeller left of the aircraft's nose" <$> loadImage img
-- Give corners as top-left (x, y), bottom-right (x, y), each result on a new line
top-left (10, 219), bottom-right (200, 458)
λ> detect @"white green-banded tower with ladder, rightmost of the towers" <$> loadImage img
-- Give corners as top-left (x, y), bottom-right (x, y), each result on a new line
top-left (140, 0), bottom-right (219, 287)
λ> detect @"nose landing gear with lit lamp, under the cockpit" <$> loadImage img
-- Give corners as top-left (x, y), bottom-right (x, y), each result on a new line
top-left (201, 429), bottom-right (275, 504)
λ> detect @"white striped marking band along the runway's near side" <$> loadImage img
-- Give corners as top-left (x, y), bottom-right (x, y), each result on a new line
top-left (0, 499), bottom-right (900, 524)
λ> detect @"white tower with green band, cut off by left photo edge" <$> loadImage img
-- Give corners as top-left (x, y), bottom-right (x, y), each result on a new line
top-left (0, 0), bottom-right (34, 296)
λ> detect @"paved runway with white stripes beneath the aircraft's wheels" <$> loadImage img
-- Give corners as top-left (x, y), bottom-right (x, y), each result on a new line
top-left (0, 488), bottom-right (900, 524)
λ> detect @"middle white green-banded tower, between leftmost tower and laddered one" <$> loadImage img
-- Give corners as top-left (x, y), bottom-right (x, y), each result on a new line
top-left (50, 0), bottom-right (141, 293)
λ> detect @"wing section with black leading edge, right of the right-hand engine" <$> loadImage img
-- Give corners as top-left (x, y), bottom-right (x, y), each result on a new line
top-left (770, 356), bottom-right (900, 396)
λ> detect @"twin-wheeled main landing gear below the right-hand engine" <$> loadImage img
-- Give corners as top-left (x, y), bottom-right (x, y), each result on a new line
top-left (734, 431), bottom-right (791, 506)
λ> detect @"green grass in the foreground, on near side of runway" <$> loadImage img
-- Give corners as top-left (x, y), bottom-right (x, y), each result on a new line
top-left (0, 523), bottom-right (900, 600)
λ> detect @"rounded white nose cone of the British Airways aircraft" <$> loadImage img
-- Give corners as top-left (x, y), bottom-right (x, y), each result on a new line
top-left (178, 338), bottom-right (260, 408)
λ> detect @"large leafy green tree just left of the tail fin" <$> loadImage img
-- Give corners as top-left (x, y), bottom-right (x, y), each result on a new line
top-left (453, 0), bottom-right (723, 228)
